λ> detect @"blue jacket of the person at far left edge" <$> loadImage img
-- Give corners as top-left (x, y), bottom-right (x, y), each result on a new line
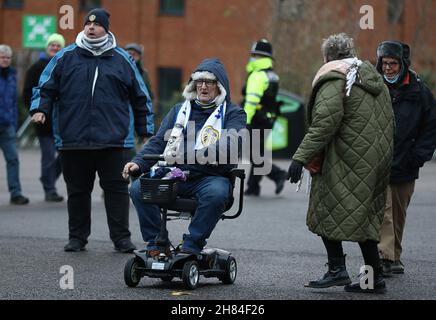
top-left (0, 67), bottom-right (18, 128)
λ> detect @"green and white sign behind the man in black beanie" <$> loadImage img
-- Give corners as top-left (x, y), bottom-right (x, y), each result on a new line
top-left (23, 15), bottom-right (56, 49)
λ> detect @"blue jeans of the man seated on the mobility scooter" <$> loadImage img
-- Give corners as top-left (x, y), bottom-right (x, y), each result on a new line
top-left (130, 176), bottom-right (232, 252)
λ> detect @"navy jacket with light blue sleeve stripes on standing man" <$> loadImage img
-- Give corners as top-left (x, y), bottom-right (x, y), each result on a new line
top-left (30, 44), bottom-right (154, 150)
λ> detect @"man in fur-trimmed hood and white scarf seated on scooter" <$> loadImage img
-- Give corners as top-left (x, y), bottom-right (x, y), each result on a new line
top-left (123, 59), bottom-right (246, 256)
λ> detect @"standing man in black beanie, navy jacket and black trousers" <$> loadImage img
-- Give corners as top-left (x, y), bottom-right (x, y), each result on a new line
top-left (30, 9), bottom-right (153, 252)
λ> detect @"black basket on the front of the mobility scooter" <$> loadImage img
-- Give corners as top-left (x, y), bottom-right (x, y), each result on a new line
top-left (140, 175), bottom-right (179, 206)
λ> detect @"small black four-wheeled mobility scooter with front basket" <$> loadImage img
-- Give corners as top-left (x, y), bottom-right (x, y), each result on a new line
top-left (124, 155), bottom-right (245, 290)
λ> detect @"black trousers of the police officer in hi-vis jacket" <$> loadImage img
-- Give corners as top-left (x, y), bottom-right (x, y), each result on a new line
top-left (247, 112), bottom-right (286, 191)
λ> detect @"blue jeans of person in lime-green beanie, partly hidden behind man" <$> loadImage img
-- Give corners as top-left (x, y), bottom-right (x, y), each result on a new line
top-left (38, 135), bottom-right (62, 193)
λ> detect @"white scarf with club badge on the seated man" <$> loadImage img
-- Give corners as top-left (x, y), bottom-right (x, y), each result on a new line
top-left (163, 100), bottom-right (227, 158)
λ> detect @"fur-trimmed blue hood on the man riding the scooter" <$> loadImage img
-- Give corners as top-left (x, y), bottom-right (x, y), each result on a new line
top-left (183, 58), bottom-right (231, 105)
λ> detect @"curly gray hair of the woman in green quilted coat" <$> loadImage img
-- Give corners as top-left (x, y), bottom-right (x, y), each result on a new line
top-left (321, 33), bottom-right (356, 62)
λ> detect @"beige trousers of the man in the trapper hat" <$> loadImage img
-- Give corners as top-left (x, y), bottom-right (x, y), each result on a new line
top-left (378, 180), bottom-right (415, 261)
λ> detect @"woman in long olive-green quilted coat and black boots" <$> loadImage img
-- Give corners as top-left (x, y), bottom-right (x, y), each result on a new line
top-left (288, 34), bottom-right (394, 293)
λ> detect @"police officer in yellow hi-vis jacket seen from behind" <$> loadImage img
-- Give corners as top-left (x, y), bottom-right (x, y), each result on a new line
top-left (242, 39), bottom-right (286, 196)
